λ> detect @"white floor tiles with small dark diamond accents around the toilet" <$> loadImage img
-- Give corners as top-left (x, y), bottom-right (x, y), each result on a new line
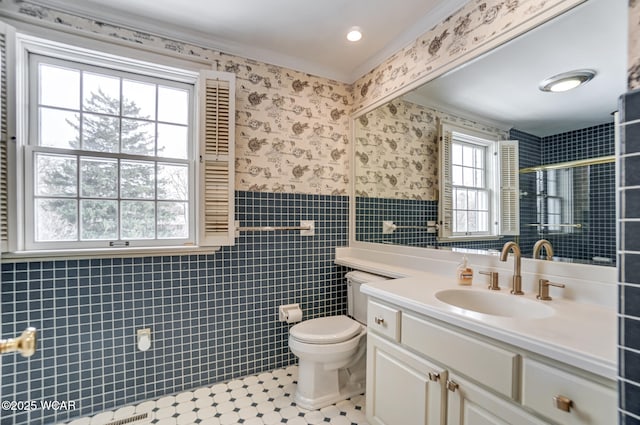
top-left (63, 366), bottom-right (367, 425)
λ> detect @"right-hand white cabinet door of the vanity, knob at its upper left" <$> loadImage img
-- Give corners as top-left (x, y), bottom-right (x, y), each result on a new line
top-left (446, 374), bottom-right (548, 425)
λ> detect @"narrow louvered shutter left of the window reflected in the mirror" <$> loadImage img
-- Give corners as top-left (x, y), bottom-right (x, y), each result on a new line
top-left (438, 125), bottom-right (453, 238)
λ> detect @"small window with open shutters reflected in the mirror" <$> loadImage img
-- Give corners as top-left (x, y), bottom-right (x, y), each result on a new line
top-left (438, 124), bottom-right (519, 240)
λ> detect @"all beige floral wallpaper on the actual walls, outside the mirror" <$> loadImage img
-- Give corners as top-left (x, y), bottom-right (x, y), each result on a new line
top-left (0, 0), bottom-right (640, 196)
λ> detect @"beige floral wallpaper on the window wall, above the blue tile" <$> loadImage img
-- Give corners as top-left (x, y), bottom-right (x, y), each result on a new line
top-left (1, 0), bottom-right (352, 195)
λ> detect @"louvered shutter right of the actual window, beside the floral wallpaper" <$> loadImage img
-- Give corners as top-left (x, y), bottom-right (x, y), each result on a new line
top-left (198, 71), bottom-right (235, 246)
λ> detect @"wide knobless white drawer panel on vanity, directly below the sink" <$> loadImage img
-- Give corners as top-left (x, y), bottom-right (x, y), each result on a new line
top-left (401, 313), bottom-right (520, 399)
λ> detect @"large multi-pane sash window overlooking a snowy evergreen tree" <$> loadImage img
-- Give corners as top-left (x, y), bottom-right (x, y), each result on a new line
top-left (25, 55), bottom-right (194, 249)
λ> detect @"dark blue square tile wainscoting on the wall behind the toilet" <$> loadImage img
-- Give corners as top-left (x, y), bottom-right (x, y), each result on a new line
top-left (0, 192), bottom-right (349, 425)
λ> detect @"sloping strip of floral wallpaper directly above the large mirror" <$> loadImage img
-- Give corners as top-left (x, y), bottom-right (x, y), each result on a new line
top-left (354, 0), bottom-right (588, 111)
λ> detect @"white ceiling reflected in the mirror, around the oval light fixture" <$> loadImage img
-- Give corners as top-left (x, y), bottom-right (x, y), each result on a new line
top-left (409, 0), bottom-right (628, 137)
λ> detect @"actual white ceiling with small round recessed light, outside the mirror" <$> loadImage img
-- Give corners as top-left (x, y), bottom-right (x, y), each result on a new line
top-left (28, 0), bottom-right (467, 83)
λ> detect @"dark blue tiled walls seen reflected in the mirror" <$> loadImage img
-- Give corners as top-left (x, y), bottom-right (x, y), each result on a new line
top-left (356, 123), bottom-right (615, 265)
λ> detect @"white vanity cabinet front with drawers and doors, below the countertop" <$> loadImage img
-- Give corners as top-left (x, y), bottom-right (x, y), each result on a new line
top-left (366, 298), bottom-right (617, 425)
